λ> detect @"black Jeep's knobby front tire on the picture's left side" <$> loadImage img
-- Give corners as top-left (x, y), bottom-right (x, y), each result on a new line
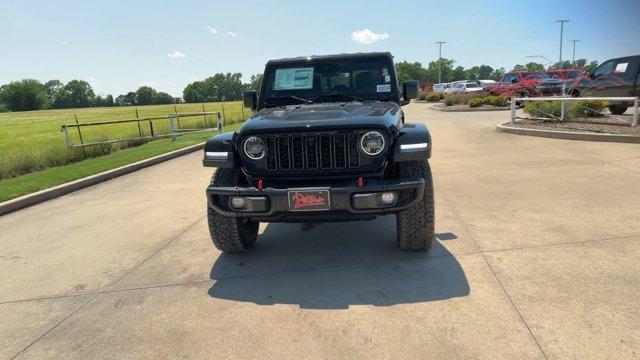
top-left (207, 168), bottom-right (260, 252)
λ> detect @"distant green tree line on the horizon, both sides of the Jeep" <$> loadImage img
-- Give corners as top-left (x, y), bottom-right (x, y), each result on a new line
top-left (0, 58), bottom-right (598, 112)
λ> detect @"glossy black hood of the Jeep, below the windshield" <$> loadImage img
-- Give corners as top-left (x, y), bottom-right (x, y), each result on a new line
top-left (238, 102), bottom-right (400, 135)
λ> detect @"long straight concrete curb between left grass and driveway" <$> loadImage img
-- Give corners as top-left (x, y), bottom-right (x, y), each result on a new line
top-left (0, 143), bottom-right (204, 215)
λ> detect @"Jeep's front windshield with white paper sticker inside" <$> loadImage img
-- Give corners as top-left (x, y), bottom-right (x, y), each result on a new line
top-left (263, 58), bottom-right (397, 106)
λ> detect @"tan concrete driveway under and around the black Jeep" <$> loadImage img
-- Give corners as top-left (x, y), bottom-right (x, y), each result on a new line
top-left (0, 103), bottom-right (640, 359)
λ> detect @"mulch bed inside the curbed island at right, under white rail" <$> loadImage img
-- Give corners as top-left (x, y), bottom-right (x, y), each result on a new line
top-left (504, 116), bottom-right (640, 136)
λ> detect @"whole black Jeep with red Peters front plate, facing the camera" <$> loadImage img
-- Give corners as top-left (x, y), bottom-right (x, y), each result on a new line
top-left (203, 53), bottom-right (434, 252)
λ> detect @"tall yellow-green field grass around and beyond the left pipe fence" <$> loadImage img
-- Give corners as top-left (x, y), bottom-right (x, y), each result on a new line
top-left (0, 101), bottom-right (251, 179)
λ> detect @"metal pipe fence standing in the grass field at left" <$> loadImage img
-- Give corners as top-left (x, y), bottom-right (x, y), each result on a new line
top-left (61, 111), bottom-right (224, 149)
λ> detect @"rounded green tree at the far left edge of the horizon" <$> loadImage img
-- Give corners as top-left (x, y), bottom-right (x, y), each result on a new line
top-left (0, 79), bottom-right (49, 111)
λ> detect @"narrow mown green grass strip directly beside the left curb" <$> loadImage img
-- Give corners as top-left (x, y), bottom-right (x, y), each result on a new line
top-left (0, 123), bottom-right (241, 202)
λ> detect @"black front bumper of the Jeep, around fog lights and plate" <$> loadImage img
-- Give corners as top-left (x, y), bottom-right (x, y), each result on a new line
top-left (206, 179), bottom-right (425, 222)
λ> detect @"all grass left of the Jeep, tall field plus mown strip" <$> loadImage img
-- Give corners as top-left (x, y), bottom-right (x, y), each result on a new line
top-left (0, 102), bottom-right (251, 202)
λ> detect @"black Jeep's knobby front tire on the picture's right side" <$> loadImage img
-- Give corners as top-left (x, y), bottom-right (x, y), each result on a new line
top-left (396, 160), bottom-right (435, 251)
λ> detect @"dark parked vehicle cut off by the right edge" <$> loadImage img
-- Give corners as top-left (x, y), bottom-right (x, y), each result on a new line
top-left (569, 55), bottom-right (640, 115)
